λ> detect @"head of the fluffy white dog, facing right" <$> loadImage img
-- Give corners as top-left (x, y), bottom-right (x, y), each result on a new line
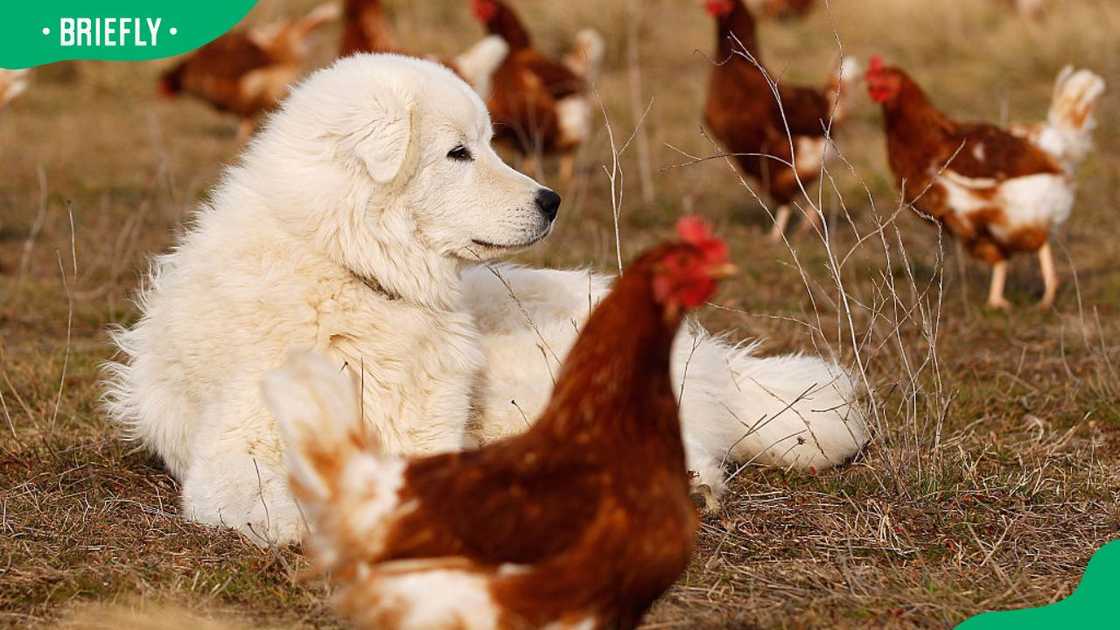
top-left (245, 55), bottom-right (560, 300)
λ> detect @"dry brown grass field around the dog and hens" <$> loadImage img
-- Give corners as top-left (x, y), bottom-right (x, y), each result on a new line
top-left (0, 0), bottom-right (1120, 628)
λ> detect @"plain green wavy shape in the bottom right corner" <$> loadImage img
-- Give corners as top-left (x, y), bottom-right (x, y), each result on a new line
top-left (956, 540), bottom-right (1120, 630)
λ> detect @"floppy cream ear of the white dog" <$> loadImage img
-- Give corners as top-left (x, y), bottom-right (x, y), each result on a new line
top-left (353, 96), bottom-right (417, 184)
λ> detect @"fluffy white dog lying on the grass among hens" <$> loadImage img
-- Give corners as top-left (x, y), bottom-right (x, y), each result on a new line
top-left (106, 55), bottom-right (867, 543)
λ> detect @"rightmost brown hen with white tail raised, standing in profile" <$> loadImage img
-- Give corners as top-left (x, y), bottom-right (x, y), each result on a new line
top-left (867, 57), bottom-right (1104, 308)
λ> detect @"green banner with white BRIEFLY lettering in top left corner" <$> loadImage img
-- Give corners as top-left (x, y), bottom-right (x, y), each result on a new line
top-left (0, 0), bottom-right (256, 70)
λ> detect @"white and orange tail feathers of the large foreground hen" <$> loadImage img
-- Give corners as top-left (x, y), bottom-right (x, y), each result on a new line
top-left (263, 352), bottom-right (404, 571)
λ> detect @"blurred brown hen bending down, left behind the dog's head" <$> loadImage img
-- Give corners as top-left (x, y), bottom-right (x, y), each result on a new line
top-left (159, 4), bottom-right (339, 141)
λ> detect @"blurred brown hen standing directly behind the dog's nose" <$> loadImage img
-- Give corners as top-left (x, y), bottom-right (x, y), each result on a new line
top-left (472, 0), bottom-right (605, 180)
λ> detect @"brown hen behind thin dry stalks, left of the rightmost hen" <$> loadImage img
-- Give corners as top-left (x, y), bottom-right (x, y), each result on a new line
top-left (704, 0), bottom-right (859, 241)
